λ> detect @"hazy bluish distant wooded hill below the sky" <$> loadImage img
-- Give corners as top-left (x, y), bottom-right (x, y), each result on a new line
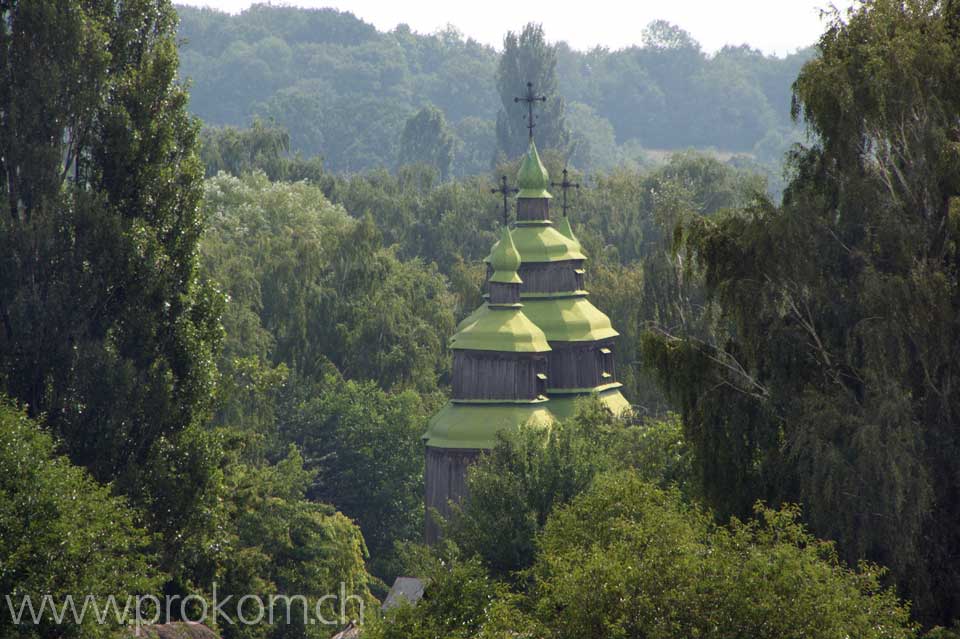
top-left (177, 5), bottom-right (812, 175)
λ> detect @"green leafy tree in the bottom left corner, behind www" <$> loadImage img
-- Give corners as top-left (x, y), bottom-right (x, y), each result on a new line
top-left (0, 398), bottom-right (162, 639)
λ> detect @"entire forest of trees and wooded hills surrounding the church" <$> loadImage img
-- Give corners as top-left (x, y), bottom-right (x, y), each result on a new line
top-left (0, 0), bottom-right (960, 639)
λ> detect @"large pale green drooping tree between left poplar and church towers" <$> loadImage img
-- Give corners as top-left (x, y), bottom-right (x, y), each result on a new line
top-left (204, 174), bottom-right (454, 392)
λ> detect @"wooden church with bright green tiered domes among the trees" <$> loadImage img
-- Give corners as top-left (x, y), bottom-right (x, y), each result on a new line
top-left (424, 127), bottom-right (629, 542)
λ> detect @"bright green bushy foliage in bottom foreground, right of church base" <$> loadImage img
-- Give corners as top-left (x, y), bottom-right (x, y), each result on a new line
top-left (368, 444), bottom-right (915, 639)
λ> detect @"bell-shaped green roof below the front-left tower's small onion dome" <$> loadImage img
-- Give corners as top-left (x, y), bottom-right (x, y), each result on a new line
top-left (450, 304), bottom-right (550, 353)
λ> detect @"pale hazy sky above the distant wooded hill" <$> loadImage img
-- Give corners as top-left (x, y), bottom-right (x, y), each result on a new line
top-left (175, 0), bottom-right (854, 55)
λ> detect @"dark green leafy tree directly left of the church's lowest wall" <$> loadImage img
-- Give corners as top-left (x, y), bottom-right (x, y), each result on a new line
top-left (279, 375), bottom-right (435, 576)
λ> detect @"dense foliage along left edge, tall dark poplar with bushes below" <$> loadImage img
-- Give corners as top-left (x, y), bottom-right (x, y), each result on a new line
top-left (0, 2), bottom-right (376, 638)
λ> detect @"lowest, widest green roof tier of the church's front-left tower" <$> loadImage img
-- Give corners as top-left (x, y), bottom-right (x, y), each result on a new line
top-left (424, 401), bottom-right (556, 449)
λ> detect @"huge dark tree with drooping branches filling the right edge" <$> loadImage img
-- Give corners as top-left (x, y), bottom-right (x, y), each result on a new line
top-left (645, 0), bottom-right (960, 623)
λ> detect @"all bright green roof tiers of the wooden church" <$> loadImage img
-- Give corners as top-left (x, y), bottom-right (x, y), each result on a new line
top-left (426, 140), bottom-right (629, 448)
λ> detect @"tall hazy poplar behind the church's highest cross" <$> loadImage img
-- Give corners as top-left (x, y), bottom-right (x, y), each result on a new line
top-left (497, 23), bottom-right (570, 159)
